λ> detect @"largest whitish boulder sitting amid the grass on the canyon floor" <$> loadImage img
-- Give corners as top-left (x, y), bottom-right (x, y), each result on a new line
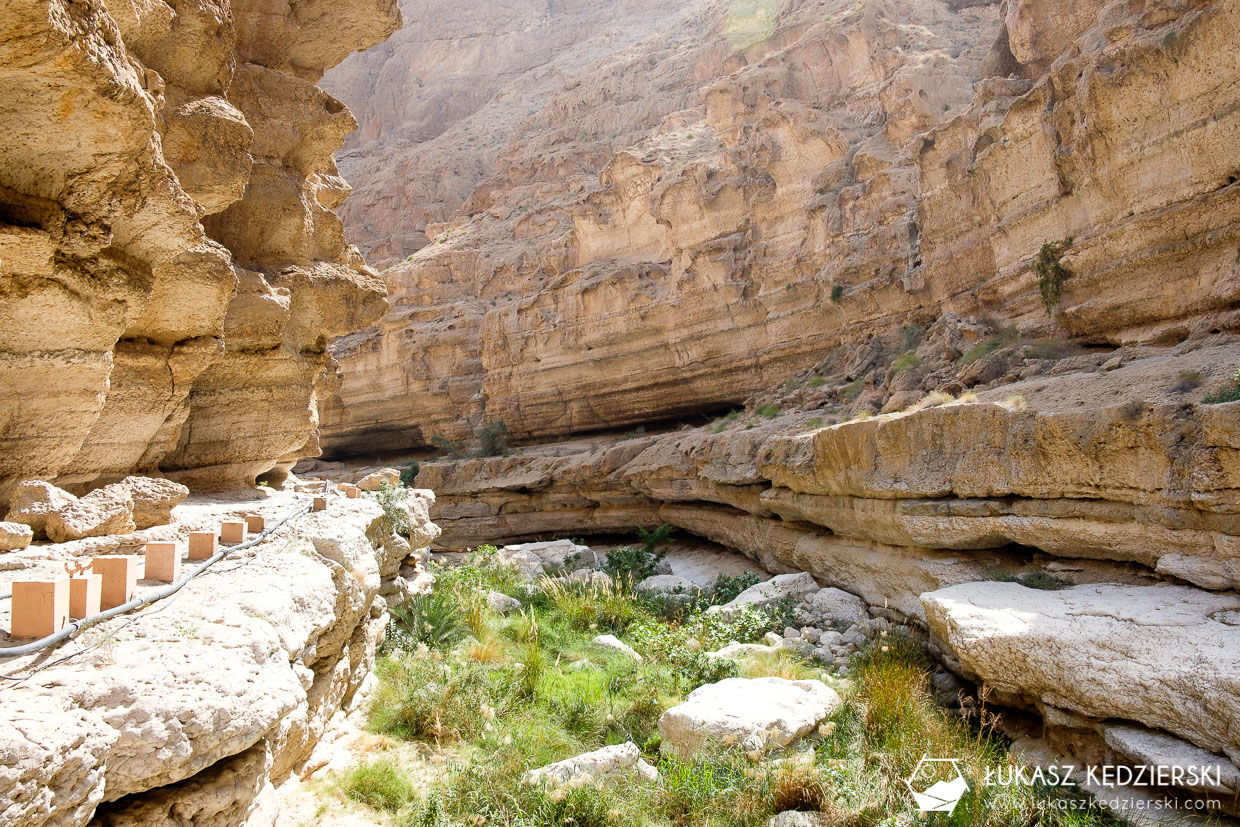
top-left (658, 678), bottom-right (841, 758)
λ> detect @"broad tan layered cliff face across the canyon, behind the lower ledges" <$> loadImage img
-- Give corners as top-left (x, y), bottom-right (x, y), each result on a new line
top-left (322, 0), bottom-right (1240, 454)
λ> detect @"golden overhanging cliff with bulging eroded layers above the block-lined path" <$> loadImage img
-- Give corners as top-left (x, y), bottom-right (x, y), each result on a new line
top-left (0, 0), bottom-right (399, 495)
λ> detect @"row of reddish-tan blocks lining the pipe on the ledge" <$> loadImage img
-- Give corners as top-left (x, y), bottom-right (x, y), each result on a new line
top-left (9, 510), bottom-right (276, 637)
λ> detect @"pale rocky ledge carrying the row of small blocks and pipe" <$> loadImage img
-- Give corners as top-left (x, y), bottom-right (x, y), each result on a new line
top-left (0, 491), bottom-right (439, 827)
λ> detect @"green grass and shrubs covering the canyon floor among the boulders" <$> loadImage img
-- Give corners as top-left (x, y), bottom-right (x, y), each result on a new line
top-left (367, 555), bottom-right (1116, 827)
